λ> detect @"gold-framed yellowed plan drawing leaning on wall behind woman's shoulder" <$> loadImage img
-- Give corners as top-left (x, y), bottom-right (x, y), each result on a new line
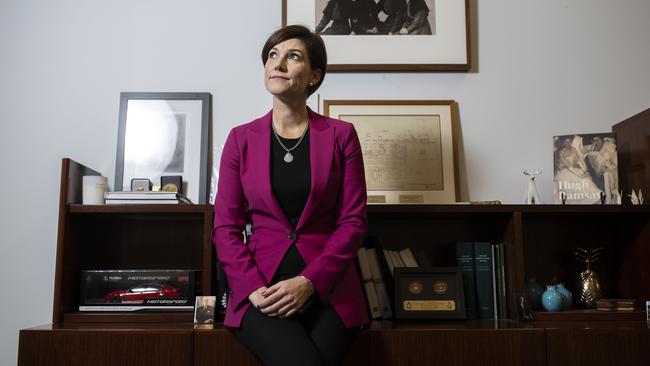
top-left (323, 100), bottom-right (459, 204)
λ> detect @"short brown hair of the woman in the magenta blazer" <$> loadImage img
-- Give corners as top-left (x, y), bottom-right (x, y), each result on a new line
top-left (262, 25), bottom-right (327, 95)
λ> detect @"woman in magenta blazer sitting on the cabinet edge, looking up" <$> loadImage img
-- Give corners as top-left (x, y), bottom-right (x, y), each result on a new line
top-left (213, 26), bottom-right (367, 365)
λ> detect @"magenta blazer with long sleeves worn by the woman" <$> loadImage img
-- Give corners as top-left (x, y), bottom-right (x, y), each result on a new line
top-left (212, 110), bottom-right (368, 327)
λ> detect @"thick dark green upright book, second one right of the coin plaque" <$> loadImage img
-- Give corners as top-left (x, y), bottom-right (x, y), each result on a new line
top-left (474, 242), bottom-right (494, 319)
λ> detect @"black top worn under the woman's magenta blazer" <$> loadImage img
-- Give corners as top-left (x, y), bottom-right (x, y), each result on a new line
top-left (271, 130), bottom-right (311, 283)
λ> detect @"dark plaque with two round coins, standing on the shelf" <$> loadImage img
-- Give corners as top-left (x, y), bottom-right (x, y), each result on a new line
top-left (394, 267), bottom-right (466, 319)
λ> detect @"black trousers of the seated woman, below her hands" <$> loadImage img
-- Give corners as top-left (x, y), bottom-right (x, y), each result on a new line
top-left (233, 302), bottom-right (359, 366)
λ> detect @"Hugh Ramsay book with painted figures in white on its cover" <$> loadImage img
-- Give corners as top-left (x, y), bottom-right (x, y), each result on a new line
top-left (553, 132), bottom-right (621, 204)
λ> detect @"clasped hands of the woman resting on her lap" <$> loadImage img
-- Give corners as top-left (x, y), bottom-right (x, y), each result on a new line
top-left (248, 276), bottom-right (314, 318)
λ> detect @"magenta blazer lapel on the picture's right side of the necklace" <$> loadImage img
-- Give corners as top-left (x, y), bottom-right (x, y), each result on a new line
top-left (294, 109), bottom-right (334, 231)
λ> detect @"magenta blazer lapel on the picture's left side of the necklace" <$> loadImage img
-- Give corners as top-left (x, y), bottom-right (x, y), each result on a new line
top-left (248, 110), bottom-right (292, 229)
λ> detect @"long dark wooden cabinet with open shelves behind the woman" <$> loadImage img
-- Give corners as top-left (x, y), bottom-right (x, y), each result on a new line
top-left (18, 159), bottom-right (650, 366)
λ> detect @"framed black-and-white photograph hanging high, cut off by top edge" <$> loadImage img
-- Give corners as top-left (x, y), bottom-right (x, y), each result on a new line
top-left (282, 0), bottom-right (471, 71)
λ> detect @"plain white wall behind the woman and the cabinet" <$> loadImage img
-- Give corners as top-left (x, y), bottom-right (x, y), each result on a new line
top-left (0, 0), bottom-right (650, 365)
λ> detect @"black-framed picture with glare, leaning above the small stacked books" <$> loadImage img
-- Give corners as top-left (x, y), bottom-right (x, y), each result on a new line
top-left (114, 93), bottom-right (212, 203)
